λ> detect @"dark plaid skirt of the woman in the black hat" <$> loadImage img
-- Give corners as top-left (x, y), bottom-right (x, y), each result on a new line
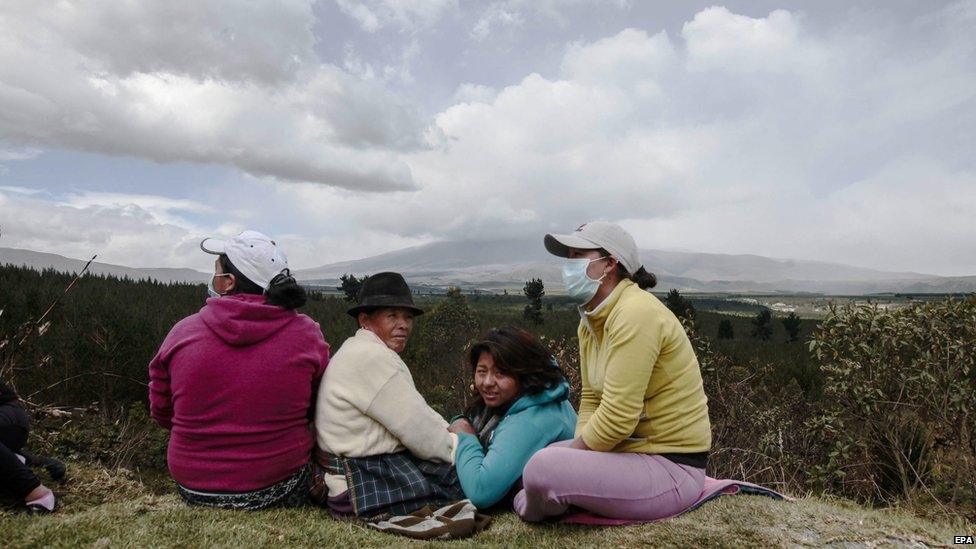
top-left (320, 451), bottom-right (465, 520)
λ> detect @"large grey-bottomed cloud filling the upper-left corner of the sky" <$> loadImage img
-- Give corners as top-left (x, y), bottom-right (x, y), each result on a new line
top-left (0, 0), bottom-right (426, 191)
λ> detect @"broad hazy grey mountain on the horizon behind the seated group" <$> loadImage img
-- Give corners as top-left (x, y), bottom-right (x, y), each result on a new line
top-left (297, 239), bottom-right (976, 294)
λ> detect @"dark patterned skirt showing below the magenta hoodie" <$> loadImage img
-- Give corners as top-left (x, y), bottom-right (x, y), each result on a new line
top-left (176, 464), bottom-right (312, 511)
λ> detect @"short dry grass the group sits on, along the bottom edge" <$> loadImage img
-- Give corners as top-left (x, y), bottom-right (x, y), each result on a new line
top-left (0, 463), bottom-right (976, 548)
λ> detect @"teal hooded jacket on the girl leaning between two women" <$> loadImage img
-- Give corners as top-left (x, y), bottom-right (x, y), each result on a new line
top-left (454, 381), bottom-right (576, 509)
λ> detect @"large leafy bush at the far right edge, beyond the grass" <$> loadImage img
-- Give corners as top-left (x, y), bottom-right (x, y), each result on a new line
top-left (810, 297), bottom-right (976, 503)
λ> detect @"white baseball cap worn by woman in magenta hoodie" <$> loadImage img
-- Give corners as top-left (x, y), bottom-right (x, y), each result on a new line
top-left (200, 231), bottom-right (288, 290)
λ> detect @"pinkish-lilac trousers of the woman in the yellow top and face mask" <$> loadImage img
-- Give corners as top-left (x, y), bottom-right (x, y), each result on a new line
top-left (514, 441), bottom-right (705, 522)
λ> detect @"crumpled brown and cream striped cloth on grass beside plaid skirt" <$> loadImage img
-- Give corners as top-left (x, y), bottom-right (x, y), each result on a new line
top-left (369, 499), bottom-right (491, 539)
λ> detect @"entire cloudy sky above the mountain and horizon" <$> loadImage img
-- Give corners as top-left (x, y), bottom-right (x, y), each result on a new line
top-left (0, 0), bottom-right (976, 275)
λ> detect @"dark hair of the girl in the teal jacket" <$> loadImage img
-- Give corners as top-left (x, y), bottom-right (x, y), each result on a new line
top-left (468, 326), bottom-right (566, 412)
